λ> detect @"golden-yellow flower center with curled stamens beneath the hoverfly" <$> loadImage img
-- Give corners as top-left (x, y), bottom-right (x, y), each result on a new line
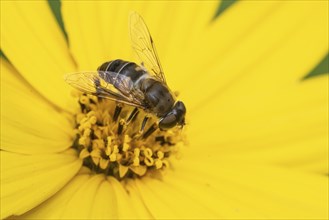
top-left (72, 94), bottom-right (183, 179)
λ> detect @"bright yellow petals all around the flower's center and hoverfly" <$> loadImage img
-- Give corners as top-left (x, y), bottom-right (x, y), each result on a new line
top-left (1, 1), bottom-right (328, 219)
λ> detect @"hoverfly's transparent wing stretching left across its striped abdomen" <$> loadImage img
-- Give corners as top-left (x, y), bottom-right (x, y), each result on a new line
top-left (65, 71), bottom-right (145, 109)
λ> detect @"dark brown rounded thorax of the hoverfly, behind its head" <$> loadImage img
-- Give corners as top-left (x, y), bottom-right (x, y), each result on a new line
top-left (141, 78), bottom-right (175, 117)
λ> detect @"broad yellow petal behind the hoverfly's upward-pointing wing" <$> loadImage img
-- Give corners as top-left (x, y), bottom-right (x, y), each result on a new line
top-left (63, 1), bottom-right (218, 76)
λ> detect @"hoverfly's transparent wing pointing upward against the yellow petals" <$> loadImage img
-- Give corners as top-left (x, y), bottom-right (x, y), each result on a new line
top-left (129, 12), bottom-right (166, 84)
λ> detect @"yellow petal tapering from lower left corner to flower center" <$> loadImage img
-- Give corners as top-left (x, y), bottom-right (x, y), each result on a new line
top-left (1, 151), bottom-right (81, 218)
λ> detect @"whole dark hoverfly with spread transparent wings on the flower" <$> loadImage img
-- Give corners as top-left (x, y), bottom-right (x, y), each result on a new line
top-left (65, 12), bottom-right (186, 130)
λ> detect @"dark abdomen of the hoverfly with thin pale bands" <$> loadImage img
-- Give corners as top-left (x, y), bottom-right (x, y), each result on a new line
top-left (97, 59), bottom-right (147, 83)
